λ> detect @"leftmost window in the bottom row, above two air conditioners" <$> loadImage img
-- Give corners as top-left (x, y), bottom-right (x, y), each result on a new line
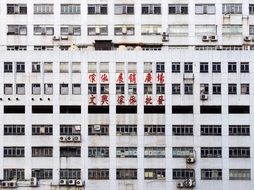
top-left (4, 168), bottom-right (25, 181)
